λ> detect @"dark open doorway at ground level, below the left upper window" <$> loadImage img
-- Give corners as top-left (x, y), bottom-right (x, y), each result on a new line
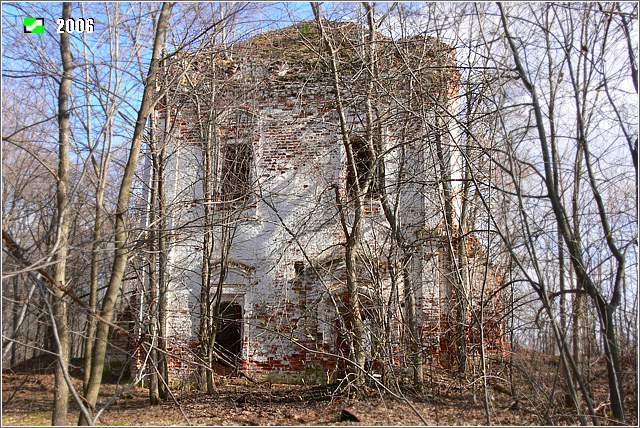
top-left (216, 302), bottom-right (242, 368)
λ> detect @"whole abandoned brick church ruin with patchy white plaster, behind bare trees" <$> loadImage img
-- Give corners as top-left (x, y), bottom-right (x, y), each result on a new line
top-left (117, 22), bottom-right (502, 382)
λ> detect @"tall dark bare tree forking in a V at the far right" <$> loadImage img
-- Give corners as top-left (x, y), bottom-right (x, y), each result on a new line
top-left (499, 5), bottom-right (626, 422)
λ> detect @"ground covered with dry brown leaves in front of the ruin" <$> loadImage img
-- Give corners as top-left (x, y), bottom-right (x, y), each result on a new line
top-left (2, 352), bottom-right (637, 426)
